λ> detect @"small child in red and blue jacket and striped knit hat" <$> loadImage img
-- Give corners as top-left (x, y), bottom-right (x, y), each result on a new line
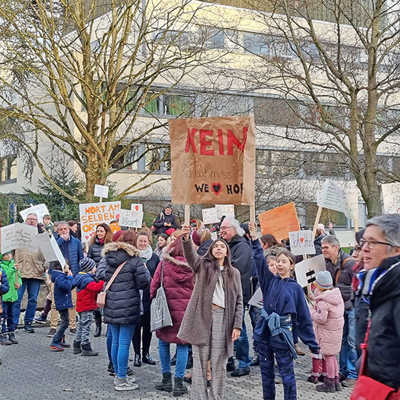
top-left (73, 257), bottom-right (104, 356)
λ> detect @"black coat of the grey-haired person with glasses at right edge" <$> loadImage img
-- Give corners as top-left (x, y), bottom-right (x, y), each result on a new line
top-left (367, 256), bottom-right (400, 388)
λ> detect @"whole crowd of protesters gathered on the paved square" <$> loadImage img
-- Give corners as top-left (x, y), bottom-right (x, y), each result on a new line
top-left (0, 200), bottom-right (400, 400)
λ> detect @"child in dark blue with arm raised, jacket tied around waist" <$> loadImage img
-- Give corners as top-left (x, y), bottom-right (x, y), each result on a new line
top-left (250, 226), bottom-right (319, 400)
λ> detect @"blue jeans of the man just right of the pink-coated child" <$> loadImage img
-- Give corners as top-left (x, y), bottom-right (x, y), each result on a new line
top-left (339, 308), bottom-right (358, 379)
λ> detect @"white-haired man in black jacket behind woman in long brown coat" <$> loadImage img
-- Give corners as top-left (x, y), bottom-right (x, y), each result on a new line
top-left (220, 217), bottom-right (252, 377)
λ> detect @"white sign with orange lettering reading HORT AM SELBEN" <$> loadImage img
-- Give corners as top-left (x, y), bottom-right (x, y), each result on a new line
top-left (79, 201), bottom-right (121, 242)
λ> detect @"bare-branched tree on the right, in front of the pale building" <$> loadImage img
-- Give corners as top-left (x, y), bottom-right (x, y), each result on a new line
top-left (220, 0), bottom-right (400, 216)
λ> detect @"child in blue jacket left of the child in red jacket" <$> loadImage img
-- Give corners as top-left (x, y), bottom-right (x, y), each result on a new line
top-left (49, 261), bottom-right (73, 351)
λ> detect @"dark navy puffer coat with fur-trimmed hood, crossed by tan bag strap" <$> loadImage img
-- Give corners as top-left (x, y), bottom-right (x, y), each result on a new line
top-left (103, 242), bottom-right (150, 325)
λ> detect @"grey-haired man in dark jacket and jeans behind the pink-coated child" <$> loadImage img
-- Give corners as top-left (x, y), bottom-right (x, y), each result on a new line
top-left (321, 235), bottom-right (358, 387)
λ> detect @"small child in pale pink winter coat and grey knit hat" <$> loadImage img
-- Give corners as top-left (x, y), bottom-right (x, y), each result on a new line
top-left (308, 271), bottom-right (344, 393)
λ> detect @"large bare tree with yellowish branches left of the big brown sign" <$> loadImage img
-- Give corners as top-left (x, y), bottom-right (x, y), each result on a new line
top-left (0, 0), bottom-right (222, 201)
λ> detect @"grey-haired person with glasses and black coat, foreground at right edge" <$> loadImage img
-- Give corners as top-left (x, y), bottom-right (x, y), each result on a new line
top-left (352, 214), bottom-right (400, 400)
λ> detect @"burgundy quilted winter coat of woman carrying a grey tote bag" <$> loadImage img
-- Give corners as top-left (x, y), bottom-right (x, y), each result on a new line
top-left (150, 249), bottom-right (193, 344)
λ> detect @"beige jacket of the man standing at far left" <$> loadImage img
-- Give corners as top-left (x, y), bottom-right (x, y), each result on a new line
top-left (14, 248), bottom-right (46, 280)
